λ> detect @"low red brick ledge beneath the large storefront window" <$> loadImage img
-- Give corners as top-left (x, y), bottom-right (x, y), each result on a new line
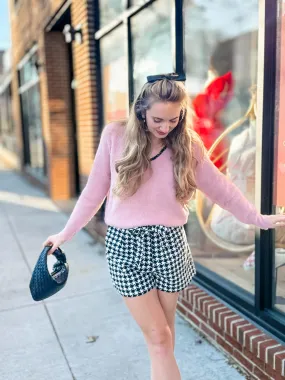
top-left (177, 285), bottom-right (285, 380)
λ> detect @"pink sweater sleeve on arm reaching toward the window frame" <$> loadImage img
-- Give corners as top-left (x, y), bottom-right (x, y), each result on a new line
top-left (195, 147), bottom-right (269, 229)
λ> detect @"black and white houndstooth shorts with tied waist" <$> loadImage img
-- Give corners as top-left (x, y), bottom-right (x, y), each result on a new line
top-left (106, 225), bottom-right (196, 297)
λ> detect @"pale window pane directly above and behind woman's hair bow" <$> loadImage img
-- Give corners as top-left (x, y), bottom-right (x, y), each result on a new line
top-left (131, 0), bottom-right (173, 95)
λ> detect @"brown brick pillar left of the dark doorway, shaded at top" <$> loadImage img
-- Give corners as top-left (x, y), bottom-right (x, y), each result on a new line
top-left (41, 32), bottom-right (75, 199)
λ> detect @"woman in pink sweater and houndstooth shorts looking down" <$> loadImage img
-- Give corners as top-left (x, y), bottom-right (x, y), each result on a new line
top-left (44, 74), bottom-right (285, 380)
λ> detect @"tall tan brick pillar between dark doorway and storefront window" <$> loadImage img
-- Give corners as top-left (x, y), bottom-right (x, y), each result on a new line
top-left (71, 0), bottom-right (99, 180)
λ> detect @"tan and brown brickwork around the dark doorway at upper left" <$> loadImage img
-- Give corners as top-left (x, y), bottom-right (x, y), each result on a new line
top-left (10, 0), bottom-right (99, 200)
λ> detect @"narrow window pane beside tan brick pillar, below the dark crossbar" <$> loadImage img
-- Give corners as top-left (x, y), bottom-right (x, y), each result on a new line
top-left (100, 26), bottom-right (128, 124)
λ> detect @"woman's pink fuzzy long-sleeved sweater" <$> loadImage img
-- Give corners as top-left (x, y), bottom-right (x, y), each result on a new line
top-left (60, 123), bottom-right (268, 241)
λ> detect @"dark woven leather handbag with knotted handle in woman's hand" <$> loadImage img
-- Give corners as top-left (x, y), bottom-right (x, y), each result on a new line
top-left (30, 246), bottom-right (69, 301)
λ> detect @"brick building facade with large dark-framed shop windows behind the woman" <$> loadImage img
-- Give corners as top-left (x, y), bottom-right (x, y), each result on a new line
top-left (3, 0), bottom-right (285, 379)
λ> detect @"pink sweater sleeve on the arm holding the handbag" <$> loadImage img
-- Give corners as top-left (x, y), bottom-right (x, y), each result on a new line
top-left (60, 124), bottom-right (112, 241)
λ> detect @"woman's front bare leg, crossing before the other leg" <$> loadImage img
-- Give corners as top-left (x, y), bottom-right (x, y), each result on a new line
top-left (124, 289), bottom-right (181, 380)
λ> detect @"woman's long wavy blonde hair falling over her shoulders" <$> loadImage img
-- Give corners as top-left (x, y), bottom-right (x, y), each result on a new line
top-left (113, 79), bottom-right (205, 207)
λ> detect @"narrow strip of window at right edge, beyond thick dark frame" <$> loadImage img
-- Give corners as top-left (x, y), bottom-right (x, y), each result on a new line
top-left (273, 0), bottom-right (285, 312)
